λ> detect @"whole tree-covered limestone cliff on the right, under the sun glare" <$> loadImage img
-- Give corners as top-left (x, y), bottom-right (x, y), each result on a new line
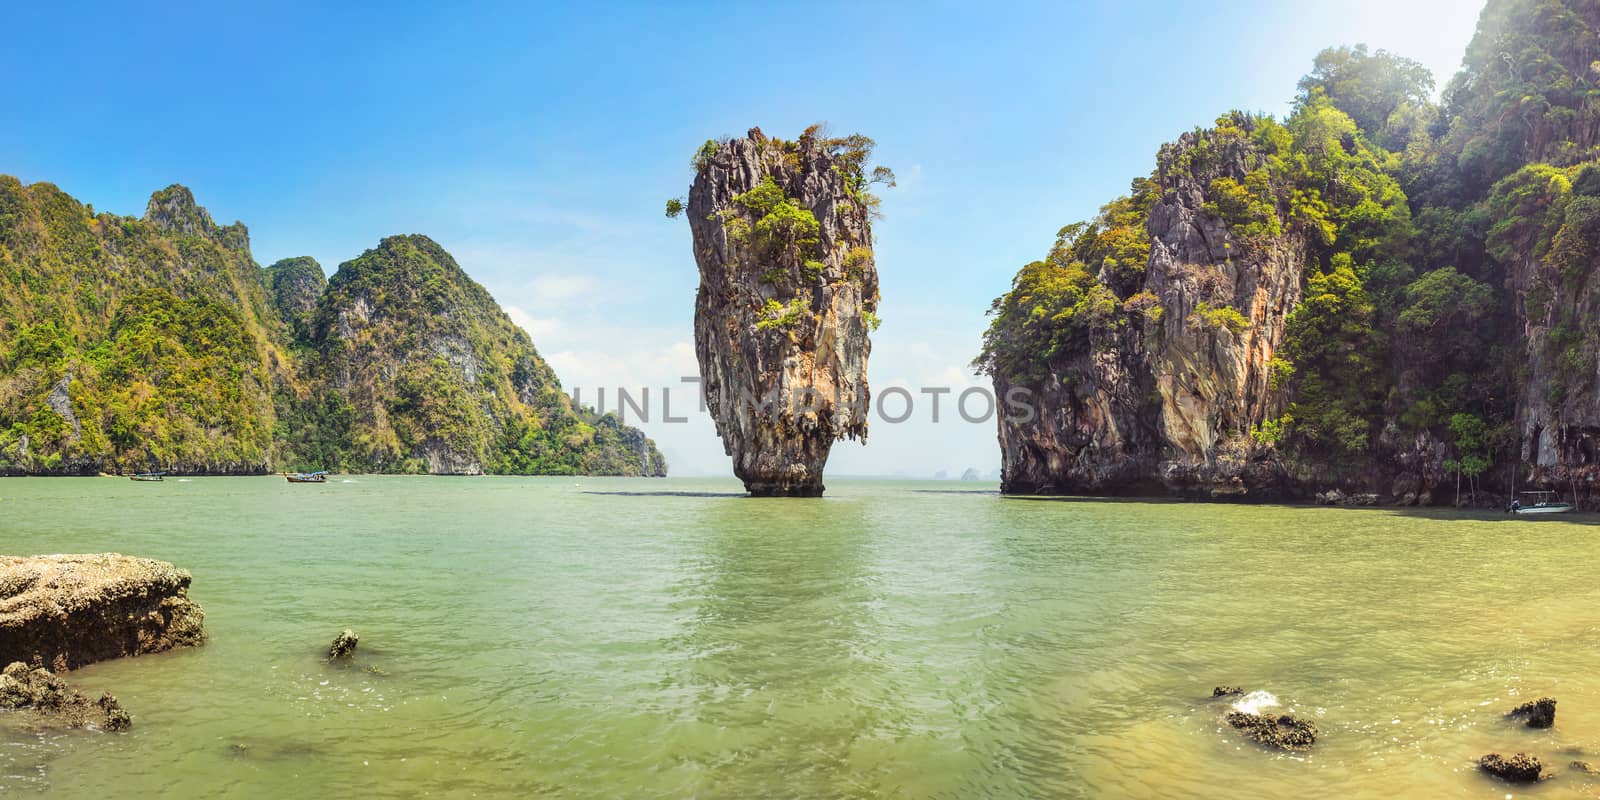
top-left (976, 0), bottom-right (1600, 506)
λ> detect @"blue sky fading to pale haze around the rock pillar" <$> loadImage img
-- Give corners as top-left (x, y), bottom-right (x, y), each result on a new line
top-left (0, 0), bottom-right (1482, 475)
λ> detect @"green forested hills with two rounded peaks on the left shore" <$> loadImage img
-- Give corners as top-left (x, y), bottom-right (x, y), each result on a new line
top-left (0, 176), bottom-right (667, 475)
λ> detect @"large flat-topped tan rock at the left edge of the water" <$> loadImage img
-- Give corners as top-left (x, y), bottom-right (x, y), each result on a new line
top-left (0, 554), bottom-right (205, 672)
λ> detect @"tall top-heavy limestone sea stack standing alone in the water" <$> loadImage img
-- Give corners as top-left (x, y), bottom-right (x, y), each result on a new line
top-left (667, 126), bottom-right (893, 498)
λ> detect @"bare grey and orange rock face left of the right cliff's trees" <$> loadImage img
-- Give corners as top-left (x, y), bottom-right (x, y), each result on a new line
top-left (995, 118), bottom-right (1306, 494)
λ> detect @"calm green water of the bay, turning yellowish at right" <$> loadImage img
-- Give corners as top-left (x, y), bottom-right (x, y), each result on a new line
top-left (0, 477), bottom-right (1600, 798)
